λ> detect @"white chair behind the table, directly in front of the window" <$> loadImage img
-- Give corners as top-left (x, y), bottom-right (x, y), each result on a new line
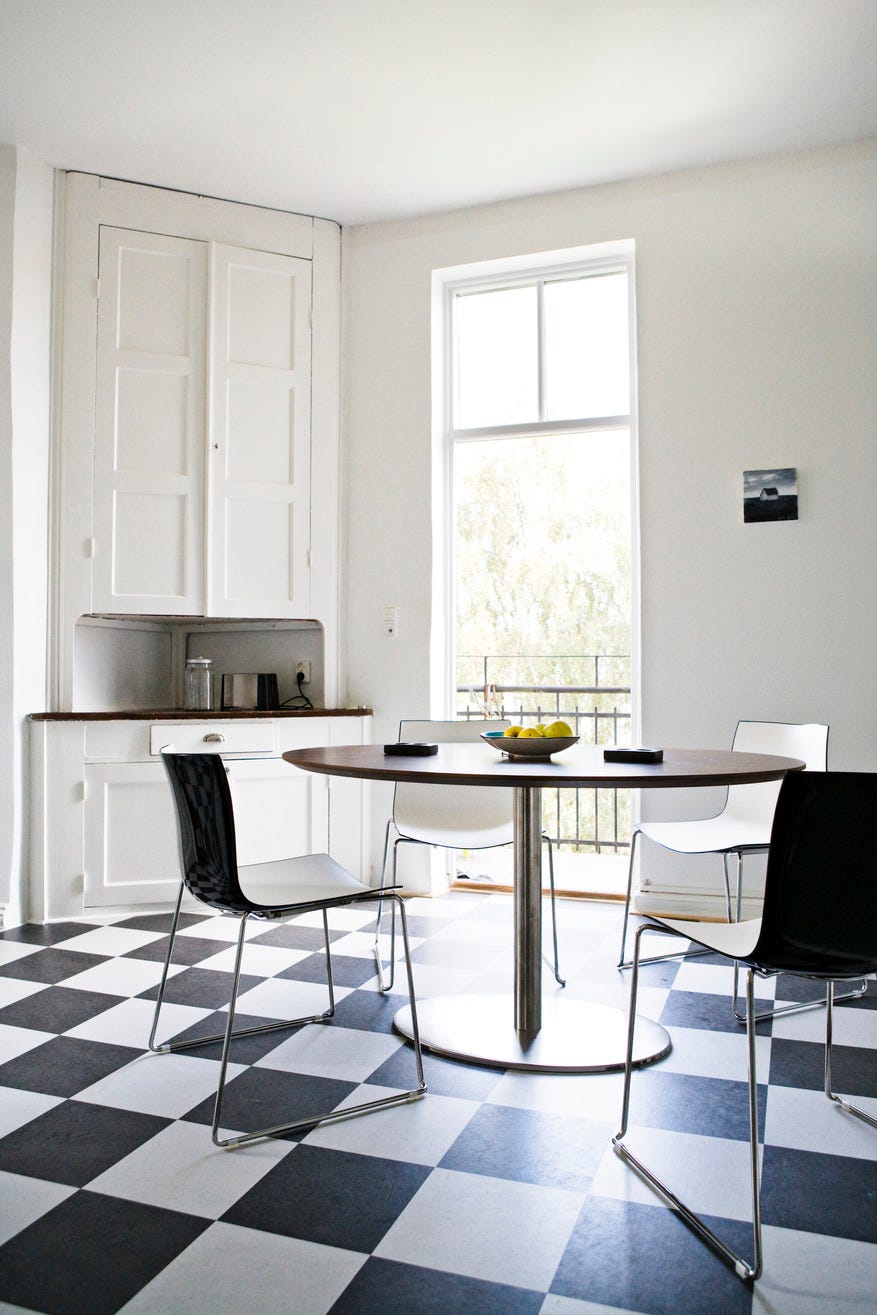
top-left (375, 718), bottom-right (567, 990)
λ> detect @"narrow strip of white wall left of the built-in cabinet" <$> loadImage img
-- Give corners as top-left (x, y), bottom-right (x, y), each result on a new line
top-left (0, 146), bottom-right (54, 921)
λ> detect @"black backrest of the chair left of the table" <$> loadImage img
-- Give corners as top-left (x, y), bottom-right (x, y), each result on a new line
top-left (162, 748), bottom-right (254, 913)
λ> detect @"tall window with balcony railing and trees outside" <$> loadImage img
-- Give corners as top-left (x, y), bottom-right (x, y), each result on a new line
top-left (435, 243), bottom-right (636, 888)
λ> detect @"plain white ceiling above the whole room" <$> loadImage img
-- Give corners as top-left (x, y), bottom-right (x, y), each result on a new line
top-left (0, 0), bottom-right (877, 224)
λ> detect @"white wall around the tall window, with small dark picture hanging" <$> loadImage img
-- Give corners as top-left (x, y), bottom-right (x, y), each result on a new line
top-left (342, 142), bottom-right (877, 883)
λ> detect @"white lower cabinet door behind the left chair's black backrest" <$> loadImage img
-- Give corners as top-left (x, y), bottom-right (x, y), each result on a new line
top-left (84, 763), bottom-right (180, 909)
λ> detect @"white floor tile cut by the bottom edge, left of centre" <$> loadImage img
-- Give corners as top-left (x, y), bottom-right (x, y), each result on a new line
top-left (118, 1223), bottom-right (367, 1315)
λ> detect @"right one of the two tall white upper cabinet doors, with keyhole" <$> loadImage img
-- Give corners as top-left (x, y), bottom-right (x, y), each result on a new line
top-left (206, 245), bottom-right (312, 617)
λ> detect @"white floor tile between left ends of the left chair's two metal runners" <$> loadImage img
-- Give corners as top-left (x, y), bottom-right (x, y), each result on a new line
top-left (76, 1055), bottom-right (243, 1119)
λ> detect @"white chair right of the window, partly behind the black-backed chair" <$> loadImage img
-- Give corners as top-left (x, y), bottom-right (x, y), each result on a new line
top-left (618, 721), bottom-right (828, 1022)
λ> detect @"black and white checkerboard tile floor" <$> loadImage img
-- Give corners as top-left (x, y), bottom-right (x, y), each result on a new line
top-left (0, 893), bottom-right (877, 1315)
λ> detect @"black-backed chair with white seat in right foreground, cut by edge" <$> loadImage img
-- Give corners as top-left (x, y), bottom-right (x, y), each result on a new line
top-left (613, 772), bottom-right (877, 1279)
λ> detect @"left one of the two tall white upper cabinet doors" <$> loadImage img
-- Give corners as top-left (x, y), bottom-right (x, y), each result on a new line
top-left (92, 227), bottom-right (208, 613)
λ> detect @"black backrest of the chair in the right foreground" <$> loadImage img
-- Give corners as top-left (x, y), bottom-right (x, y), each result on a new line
top-left (751, 772), bottom-right (877, 978)
